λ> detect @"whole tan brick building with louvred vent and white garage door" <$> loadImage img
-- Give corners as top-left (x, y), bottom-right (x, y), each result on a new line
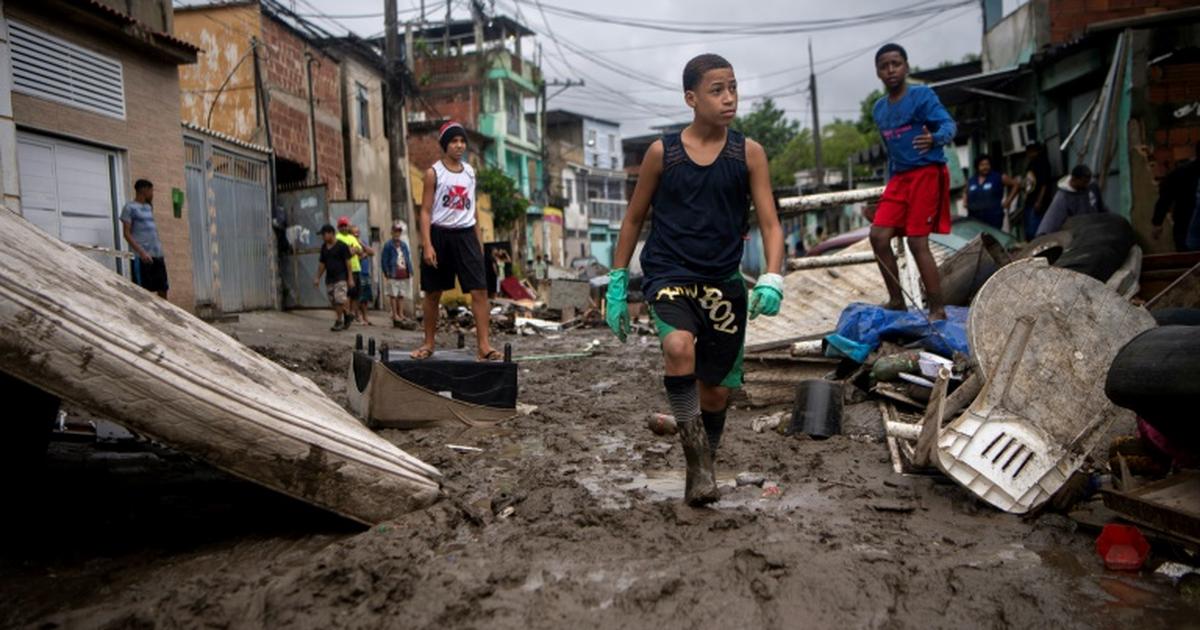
top-left (0, 0), bottom-right (198, 308)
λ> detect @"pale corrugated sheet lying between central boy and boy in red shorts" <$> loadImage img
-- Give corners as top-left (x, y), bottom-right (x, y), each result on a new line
top-left (746, 240), bottom-right (953, 353)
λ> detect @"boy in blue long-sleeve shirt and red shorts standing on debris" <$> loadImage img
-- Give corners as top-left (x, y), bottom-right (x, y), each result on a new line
top-left (871, 43), bottom-right (955, 319)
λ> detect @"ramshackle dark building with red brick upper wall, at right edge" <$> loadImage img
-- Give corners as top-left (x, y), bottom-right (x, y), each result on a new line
top-left (931, 0), bottom-right (1200, 247)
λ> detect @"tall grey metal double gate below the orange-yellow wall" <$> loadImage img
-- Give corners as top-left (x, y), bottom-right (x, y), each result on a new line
top-left (185, 138), bottom-right (277, 313)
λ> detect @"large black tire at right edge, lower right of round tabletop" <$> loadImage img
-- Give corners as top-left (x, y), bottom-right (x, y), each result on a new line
top-left (1104, 326), bottom-right (1200, 448)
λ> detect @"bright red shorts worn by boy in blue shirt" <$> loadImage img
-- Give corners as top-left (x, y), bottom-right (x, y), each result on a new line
top-left (871, 164), bottom-right (950, 236)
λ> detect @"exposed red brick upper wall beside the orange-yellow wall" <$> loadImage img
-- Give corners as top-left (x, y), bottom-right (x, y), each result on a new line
top-left (263, 17), bottom-right (346, 199)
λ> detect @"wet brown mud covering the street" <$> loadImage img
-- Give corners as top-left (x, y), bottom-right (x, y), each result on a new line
top-left (0, 313), bottom-right (1200, 630)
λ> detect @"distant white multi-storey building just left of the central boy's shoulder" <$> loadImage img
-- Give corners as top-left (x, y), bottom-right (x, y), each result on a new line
top-left (546, 109), bottom-right (628, 265)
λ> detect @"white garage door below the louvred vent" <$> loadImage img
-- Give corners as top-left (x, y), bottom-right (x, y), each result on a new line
top-left (17, 132), bottom-right (124, 272)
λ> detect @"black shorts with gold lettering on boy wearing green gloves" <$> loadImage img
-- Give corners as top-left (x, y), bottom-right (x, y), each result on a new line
top-left (647, 278), bottom-right (746, 388)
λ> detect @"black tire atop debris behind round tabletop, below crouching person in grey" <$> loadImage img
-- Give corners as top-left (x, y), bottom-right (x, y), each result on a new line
top-left (1054, 212), bottom-right (1134, 282)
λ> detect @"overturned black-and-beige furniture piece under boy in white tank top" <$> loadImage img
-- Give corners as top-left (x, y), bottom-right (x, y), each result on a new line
top-left (346, 340), bottom-right (517, 428)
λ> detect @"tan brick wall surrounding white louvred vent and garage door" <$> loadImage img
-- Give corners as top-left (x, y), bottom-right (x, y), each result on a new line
top-left (4, 5), bottom-right (196, 310)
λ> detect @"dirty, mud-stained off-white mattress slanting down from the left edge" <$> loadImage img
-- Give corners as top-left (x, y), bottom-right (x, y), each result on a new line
top-left (0, 209), bottom-right (440, 523)
